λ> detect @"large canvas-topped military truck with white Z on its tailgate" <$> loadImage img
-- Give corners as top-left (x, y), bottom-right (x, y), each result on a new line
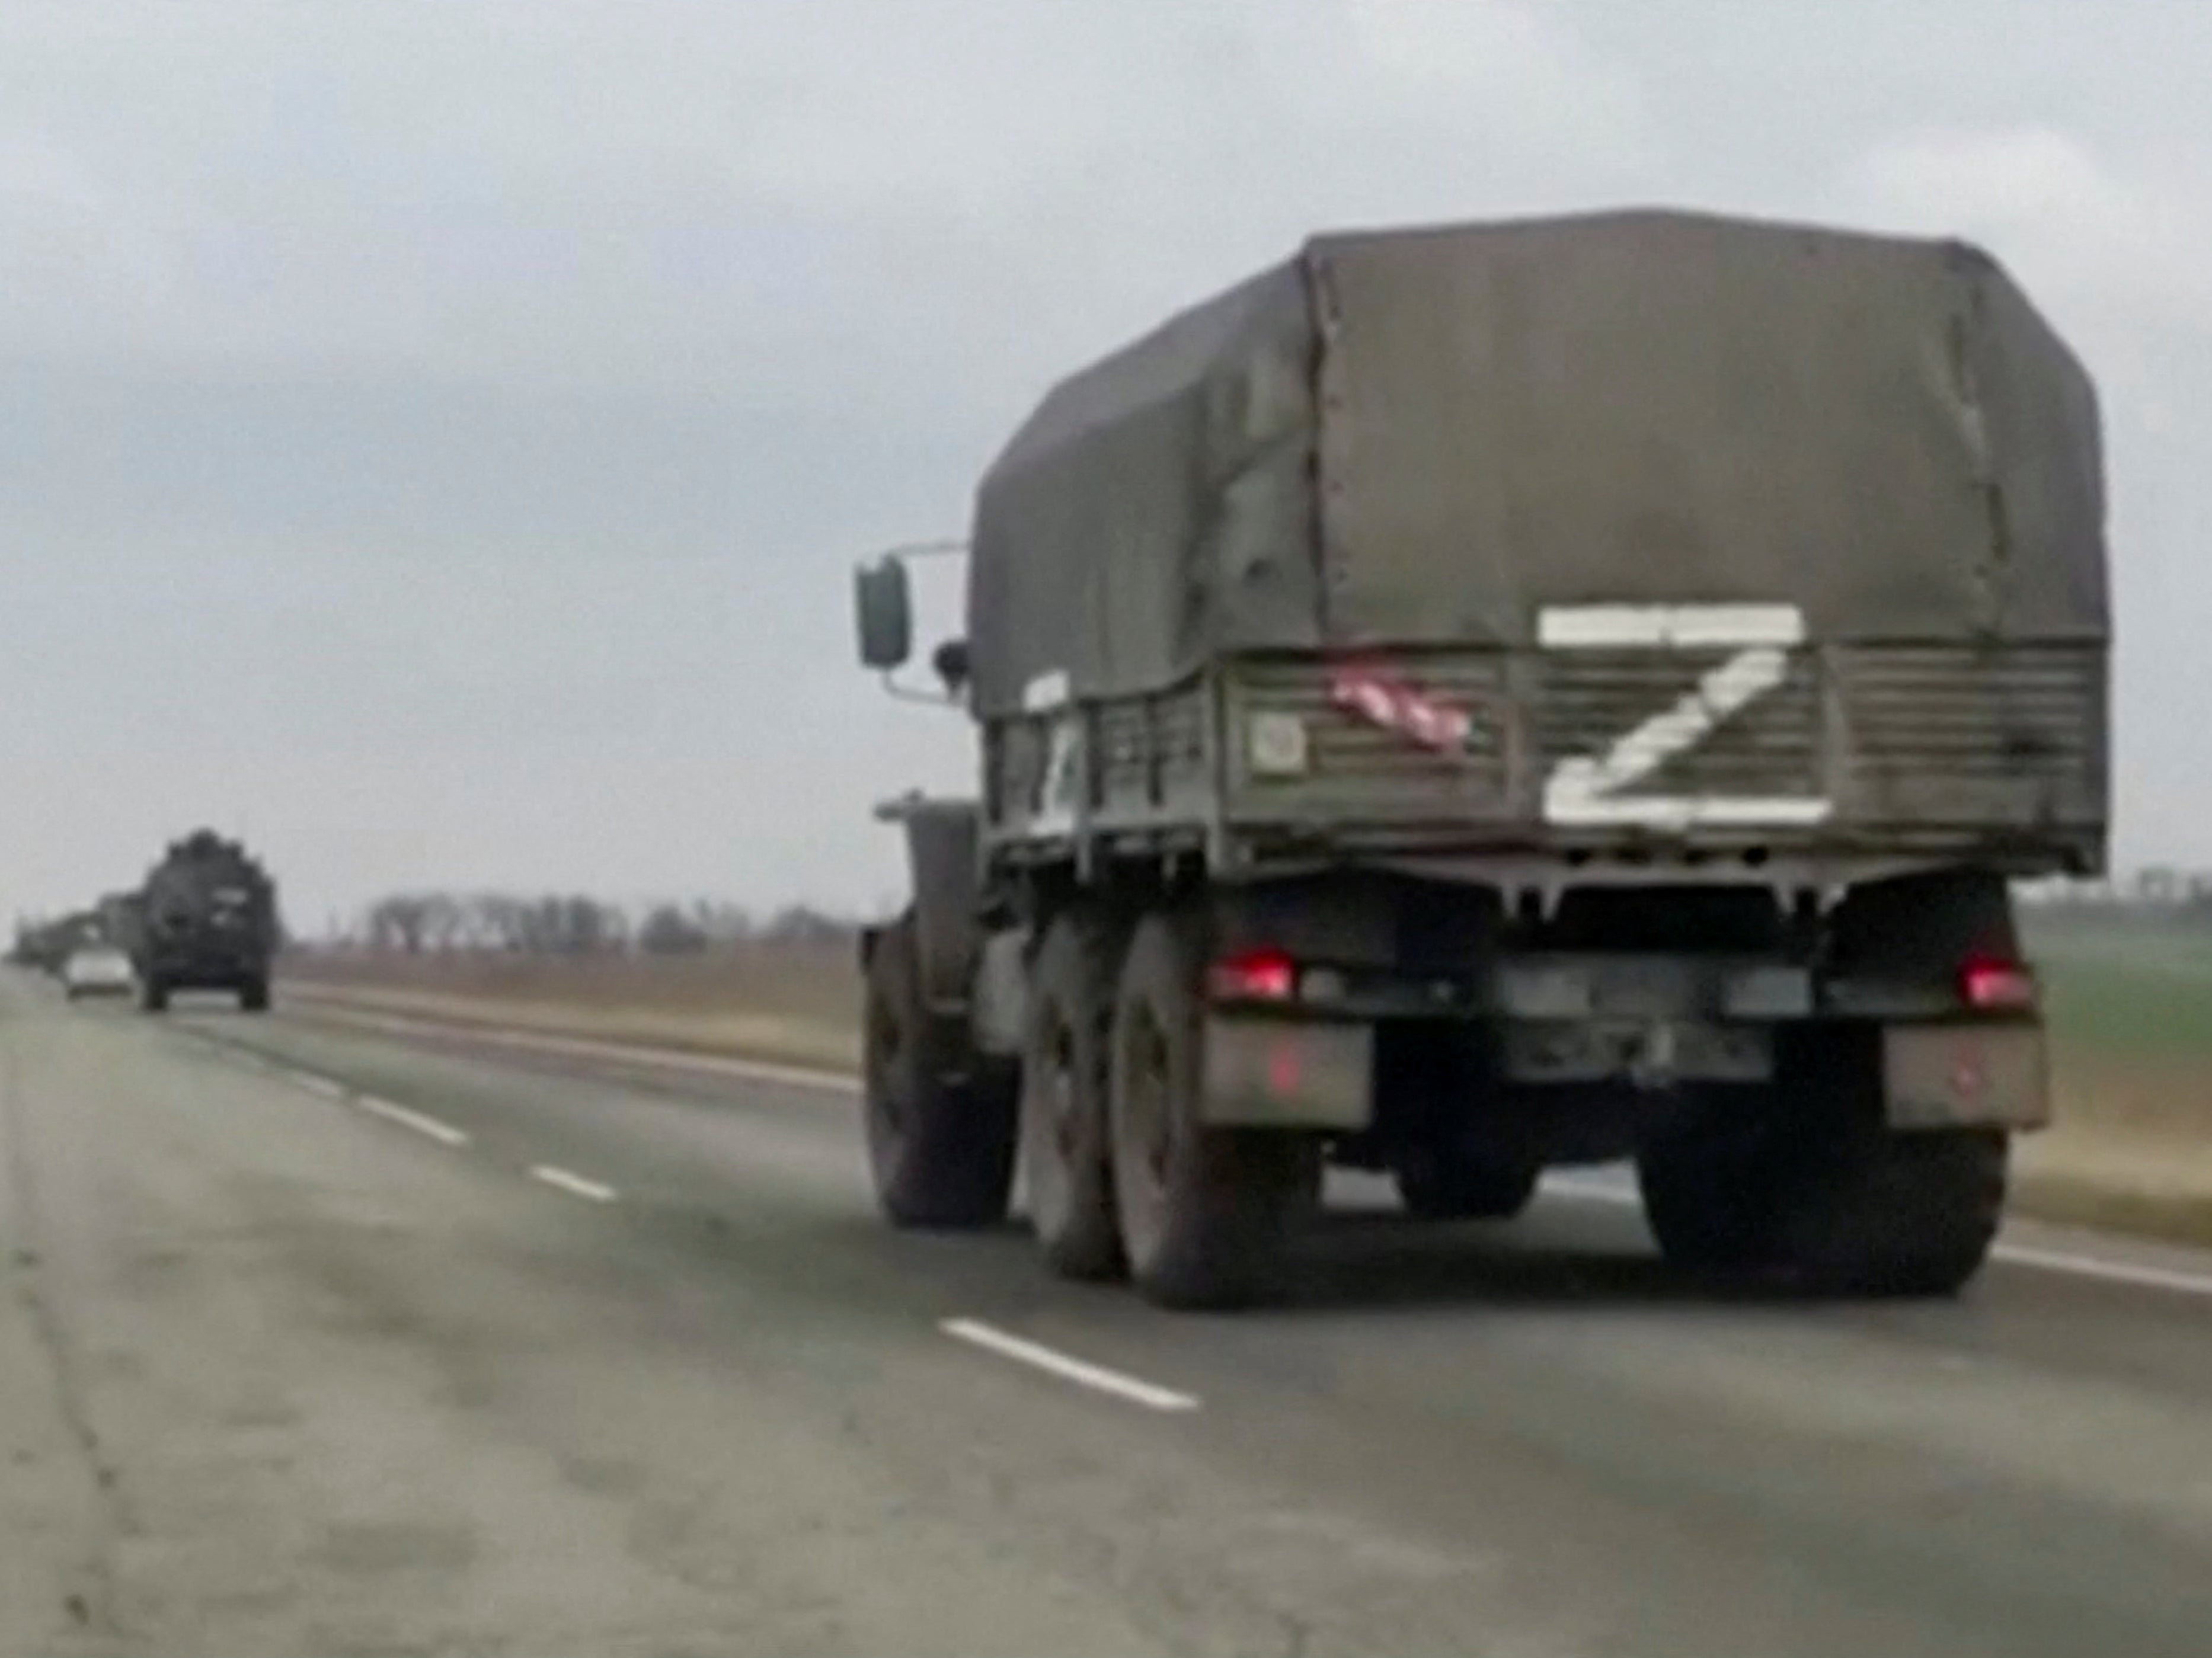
top-left (856, 212), bottom-right (2110, 1307)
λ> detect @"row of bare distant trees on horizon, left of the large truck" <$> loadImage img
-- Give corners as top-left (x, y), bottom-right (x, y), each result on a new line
top-left (323, 893), bottom-right (856, 955)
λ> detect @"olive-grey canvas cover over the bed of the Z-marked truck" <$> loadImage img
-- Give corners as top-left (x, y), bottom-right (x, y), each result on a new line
top-left (969, 212), bottom-right (2108, 716)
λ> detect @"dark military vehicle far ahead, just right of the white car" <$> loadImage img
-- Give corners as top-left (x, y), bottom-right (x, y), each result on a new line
top-left (128, 829), bottom-right (277, 1013)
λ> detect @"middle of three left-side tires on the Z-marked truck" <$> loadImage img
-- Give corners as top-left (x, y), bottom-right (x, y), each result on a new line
top-left (1022, 908), bottom-right (1126, 1280)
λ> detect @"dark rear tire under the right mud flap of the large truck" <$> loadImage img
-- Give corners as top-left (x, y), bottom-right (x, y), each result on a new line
top-left (1781, 1128), bottom-right (2006, 1295)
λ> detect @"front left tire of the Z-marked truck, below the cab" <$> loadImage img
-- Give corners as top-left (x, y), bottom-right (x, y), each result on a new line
top-left (862, 911), bottom-right (1018, 1229)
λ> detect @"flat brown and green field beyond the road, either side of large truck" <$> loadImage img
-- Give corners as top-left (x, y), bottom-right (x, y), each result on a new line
top-left (292, 917), bottom-right (2212, 1240)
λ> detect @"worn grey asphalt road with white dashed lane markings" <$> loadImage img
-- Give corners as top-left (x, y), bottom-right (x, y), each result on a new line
top-left (0, 981), bottom-right (2212, 1658)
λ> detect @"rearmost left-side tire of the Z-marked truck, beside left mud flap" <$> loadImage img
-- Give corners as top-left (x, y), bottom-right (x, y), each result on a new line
top-left (1110, 915), bottom-right (1321, 1309)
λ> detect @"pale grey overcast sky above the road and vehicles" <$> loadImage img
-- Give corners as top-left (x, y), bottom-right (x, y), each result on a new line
top-left (0, 0), bottom-right (2212, 926)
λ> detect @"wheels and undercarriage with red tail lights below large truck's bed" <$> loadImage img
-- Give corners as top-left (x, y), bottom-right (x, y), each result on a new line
top-left (867, 836), bottom-right (2048, 1307)
